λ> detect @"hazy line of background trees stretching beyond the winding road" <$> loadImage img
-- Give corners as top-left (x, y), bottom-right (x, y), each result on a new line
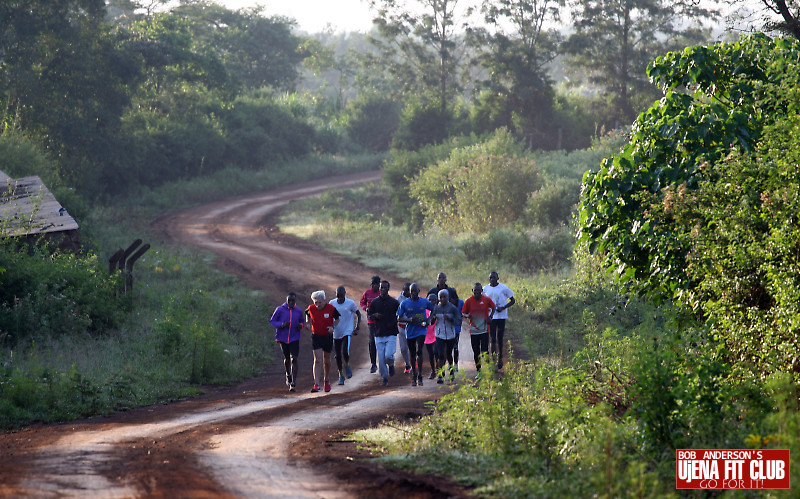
top-left (0, 0), bottom-right (724, 199)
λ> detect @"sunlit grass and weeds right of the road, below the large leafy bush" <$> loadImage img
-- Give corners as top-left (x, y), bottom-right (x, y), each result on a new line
top-left (281, 174), bottom-right (800, 498)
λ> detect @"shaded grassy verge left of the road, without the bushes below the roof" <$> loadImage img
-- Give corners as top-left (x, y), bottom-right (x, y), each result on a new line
top-left (0, 155), bottom-right (380, 428)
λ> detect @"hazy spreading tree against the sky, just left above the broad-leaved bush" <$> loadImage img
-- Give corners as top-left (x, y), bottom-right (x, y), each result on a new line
top-left (566, 0), bottom-right (716, 122)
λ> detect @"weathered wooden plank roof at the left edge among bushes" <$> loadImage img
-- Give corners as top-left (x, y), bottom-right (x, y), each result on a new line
top-left (0, 172), bottom-right (81, 252)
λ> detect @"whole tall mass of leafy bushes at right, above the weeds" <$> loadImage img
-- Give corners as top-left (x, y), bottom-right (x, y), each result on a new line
top-left (580, 36), bottom-right (800, 380)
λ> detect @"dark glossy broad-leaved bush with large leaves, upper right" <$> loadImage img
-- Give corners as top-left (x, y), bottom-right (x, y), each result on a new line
top-left (579, 35), bottom-right (800, 298)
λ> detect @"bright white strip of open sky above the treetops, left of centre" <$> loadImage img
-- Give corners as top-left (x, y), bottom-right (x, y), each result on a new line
top-left (216, 0), bottom-right (372, 33)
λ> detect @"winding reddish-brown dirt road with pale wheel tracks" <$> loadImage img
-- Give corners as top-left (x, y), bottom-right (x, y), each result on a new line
top-left (0, 172), bottom-right (474, 498)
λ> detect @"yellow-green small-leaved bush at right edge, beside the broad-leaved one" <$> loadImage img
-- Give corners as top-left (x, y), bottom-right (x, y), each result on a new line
top-left (663, 115), bottom-right (800, 380)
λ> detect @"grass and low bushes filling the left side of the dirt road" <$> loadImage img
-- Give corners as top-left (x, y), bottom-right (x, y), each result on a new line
top-left (0, 153), bottom-right (381, 428)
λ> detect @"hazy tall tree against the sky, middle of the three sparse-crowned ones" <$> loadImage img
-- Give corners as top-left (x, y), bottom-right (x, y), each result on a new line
top-left (469, 0), bottom-right (564, 146)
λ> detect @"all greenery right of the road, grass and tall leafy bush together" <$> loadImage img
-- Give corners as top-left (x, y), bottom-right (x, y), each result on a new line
top-left (280, 36), bottom-right (800, 497)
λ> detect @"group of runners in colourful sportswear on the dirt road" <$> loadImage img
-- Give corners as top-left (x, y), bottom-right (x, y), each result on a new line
top-left (270, 271), bottom-right (515, 392)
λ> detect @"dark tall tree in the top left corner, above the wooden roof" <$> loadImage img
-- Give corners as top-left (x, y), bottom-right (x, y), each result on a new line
top-left (0, 0), bottom-right (140, 190)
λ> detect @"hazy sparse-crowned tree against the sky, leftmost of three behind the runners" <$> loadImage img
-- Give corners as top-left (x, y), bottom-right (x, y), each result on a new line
top-left (369, 0), bottom-right (462, 113)
